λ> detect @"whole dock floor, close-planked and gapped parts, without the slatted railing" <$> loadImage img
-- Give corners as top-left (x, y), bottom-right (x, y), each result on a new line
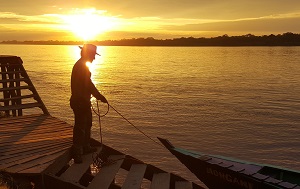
top-left (0, 115), bottom-right (201, 189)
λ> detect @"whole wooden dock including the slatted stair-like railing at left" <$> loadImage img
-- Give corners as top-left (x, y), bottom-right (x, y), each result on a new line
top-left (0, 55), bottom-right (205, 189)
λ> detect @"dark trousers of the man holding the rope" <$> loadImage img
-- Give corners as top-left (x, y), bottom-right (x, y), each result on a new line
top-left (73, 105), bottom-right (92, 154)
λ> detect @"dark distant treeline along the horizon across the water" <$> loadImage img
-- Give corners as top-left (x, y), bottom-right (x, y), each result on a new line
top-left (1, 32), bottom-right (300, 46)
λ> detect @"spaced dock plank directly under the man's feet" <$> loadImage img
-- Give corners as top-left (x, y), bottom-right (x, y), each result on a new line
top-left (60, 148), bottom-right (100, 183)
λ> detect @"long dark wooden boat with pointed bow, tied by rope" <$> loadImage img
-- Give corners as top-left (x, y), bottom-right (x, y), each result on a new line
top-left (158, 138), bottom-right (300, 189)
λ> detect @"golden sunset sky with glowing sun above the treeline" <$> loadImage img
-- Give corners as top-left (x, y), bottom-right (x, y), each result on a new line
top-left (0, 0), bottom-right (300, 41)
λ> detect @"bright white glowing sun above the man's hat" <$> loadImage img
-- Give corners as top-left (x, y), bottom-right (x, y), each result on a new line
top-left (63, 9), bottom-right (117, 41)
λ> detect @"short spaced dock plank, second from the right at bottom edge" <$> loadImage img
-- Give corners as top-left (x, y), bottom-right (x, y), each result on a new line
top-left (150, 173), bottom-right (171, 189)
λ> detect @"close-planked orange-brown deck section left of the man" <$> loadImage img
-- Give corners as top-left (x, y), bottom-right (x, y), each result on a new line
top-left (0, 115), bottom-right (72, 174)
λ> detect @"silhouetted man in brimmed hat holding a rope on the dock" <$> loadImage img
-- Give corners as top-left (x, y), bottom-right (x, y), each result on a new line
top-left (70, 44), bottom-right (107, 163)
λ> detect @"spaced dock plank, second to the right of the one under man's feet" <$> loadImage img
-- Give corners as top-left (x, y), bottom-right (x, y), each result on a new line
top-left (122, 164), bottom-right (147, 189)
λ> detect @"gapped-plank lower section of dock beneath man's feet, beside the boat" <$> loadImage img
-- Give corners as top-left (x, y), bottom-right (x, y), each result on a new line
top-left (44, 141), bottom-right (202, 189)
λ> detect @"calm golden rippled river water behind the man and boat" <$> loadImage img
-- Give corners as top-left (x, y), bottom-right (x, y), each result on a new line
top-left (0, 45), bottom-right (300, 187)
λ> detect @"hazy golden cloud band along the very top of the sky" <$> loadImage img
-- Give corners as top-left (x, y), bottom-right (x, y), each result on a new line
top-left (0, 0), bottom-right (300, 19)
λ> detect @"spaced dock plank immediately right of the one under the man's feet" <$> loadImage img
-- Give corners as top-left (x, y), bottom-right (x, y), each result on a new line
top-left (87, 155), bottom-right (125, 189)
